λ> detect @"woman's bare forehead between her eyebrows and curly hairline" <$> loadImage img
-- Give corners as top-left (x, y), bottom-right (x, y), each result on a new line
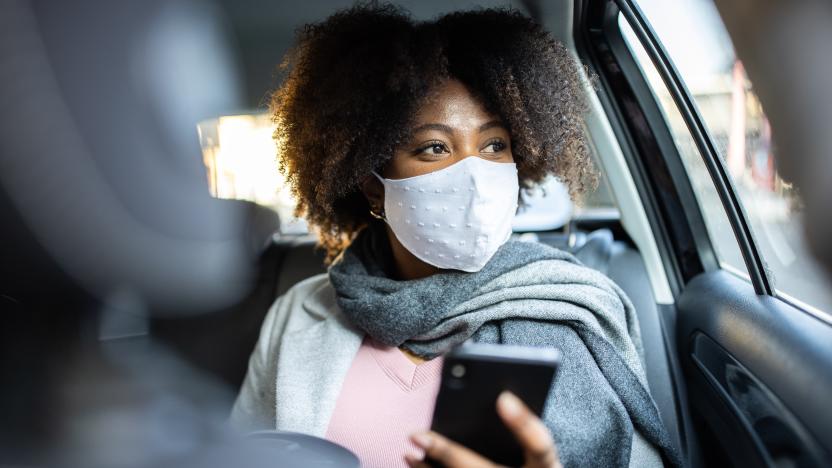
top-left (414, 79), bottom-right (499, 129)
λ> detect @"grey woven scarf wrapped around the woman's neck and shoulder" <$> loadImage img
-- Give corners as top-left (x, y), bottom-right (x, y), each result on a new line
top-left (329, 223), bottom-right (681, 467)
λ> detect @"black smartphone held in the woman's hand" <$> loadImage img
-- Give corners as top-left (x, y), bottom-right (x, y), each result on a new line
top-left (426, 343), bottom-right (560, 466)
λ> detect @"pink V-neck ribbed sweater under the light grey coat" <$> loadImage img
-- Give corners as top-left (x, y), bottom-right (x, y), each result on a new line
top-left (326, 337), bottom-right (442, 468)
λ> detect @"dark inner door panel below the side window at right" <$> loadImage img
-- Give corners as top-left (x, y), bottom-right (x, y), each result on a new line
top-left (678, 271), bottom-right (832, 466)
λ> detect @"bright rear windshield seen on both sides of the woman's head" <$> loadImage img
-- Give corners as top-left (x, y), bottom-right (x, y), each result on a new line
top-left (197, 113), bottom-right (618, 234)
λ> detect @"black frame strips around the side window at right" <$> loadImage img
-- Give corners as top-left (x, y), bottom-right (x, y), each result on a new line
top-left (576, 0), bottom-right (777, 297)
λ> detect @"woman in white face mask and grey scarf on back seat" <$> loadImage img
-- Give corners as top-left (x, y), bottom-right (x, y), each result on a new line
top-left (232, 6), bottom-right (675, 466)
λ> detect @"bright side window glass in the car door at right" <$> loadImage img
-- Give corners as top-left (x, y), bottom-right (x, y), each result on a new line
top-left (619, 0), bottom-right (832, 313)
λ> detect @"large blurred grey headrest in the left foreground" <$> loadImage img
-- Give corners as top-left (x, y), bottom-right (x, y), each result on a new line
top-left (0, 0), bottom-right (253, 311)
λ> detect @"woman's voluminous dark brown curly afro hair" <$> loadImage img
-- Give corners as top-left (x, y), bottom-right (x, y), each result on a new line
top-left (271, 1), bottom-right (596, 262)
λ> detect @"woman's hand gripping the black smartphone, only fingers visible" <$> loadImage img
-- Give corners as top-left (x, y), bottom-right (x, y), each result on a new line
top-left (405, 392), bottom-right (561, 468)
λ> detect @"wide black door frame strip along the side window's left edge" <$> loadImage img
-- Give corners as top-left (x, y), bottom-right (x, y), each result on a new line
top-left (575, 0), bottom-right (718, 297)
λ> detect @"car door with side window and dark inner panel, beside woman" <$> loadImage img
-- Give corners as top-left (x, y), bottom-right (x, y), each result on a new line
top-left (575, 0), bottom-right (832, 466)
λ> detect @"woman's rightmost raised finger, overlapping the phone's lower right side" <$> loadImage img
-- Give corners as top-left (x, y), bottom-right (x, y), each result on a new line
top-left (497, 392), bottom-right (561, 468)
